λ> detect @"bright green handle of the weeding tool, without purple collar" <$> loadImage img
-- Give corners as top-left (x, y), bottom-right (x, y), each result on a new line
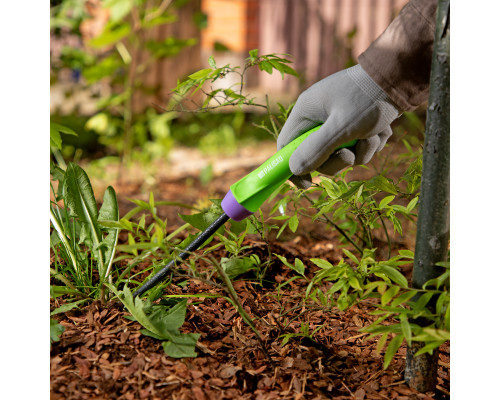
top-left (231, 125), bottom-right (357, 213)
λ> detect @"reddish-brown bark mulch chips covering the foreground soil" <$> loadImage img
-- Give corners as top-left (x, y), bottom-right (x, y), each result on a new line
top-left (50, 242), bottom-right (450, 400)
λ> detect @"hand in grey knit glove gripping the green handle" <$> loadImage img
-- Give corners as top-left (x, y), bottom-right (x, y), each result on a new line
top-left (278, 65), bottom-right (400, 189)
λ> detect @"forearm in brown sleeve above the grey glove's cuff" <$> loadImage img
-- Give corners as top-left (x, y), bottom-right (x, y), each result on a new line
top-left (359, 0), bottom-right (437, 111)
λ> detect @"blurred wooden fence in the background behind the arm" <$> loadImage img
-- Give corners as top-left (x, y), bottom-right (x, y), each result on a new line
top-left (202, 0), bottom-right (407, 96)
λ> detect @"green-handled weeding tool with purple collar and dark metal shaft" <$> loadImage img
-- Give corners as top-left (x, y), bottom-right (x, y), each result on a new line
top-left (134, 126), bottom-right (357, 297)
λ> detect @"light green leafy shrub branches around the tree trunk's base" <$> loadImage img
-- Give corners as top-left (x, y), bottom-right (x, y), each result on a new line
top-left (306, 249), bottom-right (450, 368)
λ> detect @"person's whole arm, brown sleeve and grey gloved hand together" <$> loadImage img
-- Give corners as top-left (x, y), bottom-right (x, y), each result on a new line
top-left (278, 0), bottom-right (436, 188)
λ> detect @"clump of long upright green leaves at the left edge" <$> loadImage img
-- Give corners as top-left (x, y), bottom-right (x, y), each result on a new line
top-left (50, 163), bottom-right (119, 300)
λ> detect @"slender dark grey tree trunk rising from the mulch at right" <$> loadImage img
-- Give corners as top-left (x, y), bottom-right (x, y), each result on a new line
top-left (405, 0), bottom-right (450, 392)
